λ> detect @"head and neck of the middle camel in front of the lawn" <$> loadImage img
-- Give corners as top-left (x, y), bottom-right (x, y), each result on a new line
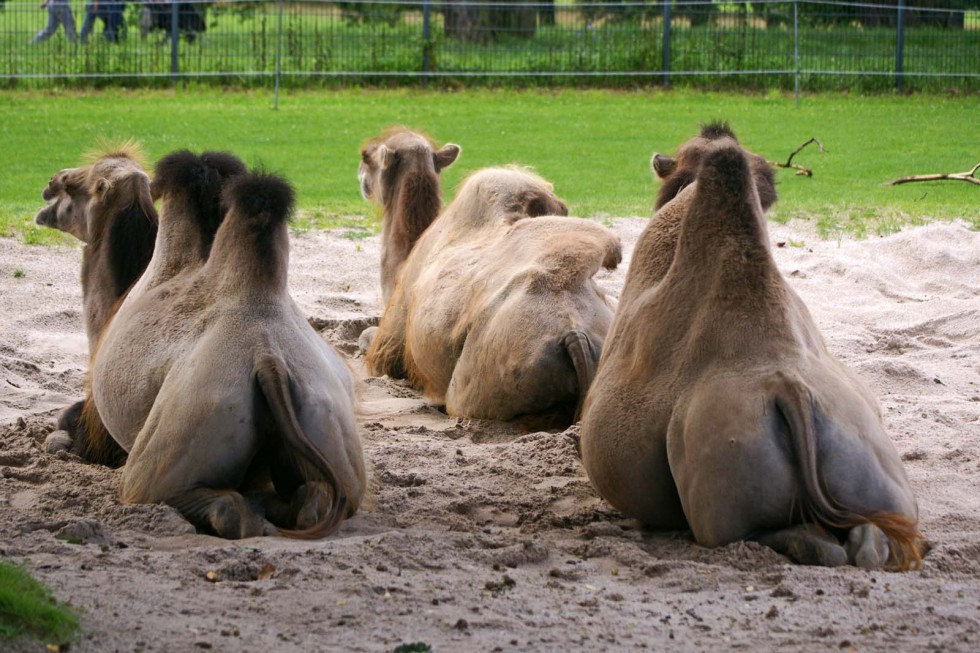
top-left (357, 127), bottom-right (460, 303)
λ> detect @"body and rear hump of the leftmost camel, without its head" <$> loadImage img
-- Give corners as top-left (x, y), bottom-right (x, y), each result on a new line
top-left (92, 166), bottom-right (366, 538)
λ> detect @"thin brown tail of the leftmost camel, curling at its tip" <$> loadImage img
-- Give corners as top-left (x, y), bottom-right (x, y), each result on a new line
top-left (255, 354), bottom-right (348, 539)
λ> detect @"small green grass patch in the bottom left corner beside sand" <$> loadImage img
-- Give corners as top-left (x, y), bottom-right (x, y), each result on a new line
top-left (0, 561), bottom-right (78, 650)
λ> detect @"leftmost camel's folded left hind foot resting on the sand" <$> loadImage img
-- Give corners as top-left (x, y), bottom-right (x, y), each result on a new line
top-left (166, 488), bottom-right (276, 540)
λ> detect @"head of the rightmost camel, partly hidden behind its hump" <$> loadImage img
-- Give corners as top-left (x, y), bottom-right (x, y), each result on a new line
top-left (650, 122), bottom-right (776, 211)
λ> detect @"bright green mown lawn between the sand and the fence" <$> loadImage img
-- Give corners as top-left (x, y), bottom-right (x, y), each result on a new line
top-left (0, 87), bottom-right (980, 242)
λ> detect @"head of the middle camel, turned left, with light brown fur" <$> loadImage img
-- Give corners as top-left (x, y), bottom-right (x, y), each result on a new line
top-left (357, 127), bottom-right (461, 206)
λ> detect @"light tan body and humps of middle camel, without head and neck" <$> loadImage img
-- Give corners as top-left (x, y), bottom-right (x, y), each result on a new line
top-left (367, 168), bottom-right (622, 424)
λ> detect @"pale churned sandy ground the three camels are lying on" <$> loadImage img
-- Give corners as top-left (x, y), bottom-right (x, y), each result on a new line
top-left (0, 219), bottom-right (980, 652)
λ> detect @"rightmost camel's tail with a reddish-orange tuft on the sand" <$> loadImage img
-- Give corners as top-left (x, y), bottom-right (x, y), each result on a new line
top-left (776, 378), bottom-right (925, 571)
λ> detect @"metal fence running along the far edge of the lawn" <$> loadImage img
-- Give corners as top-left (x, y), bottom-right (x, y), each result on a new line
top-left (0, 0), bottom-right (980, 92)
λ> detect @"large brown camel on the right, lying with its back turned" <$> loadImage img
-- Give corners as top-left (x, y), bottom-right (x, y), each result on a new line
top-left (581, 126), bottom-right (922, 568)
